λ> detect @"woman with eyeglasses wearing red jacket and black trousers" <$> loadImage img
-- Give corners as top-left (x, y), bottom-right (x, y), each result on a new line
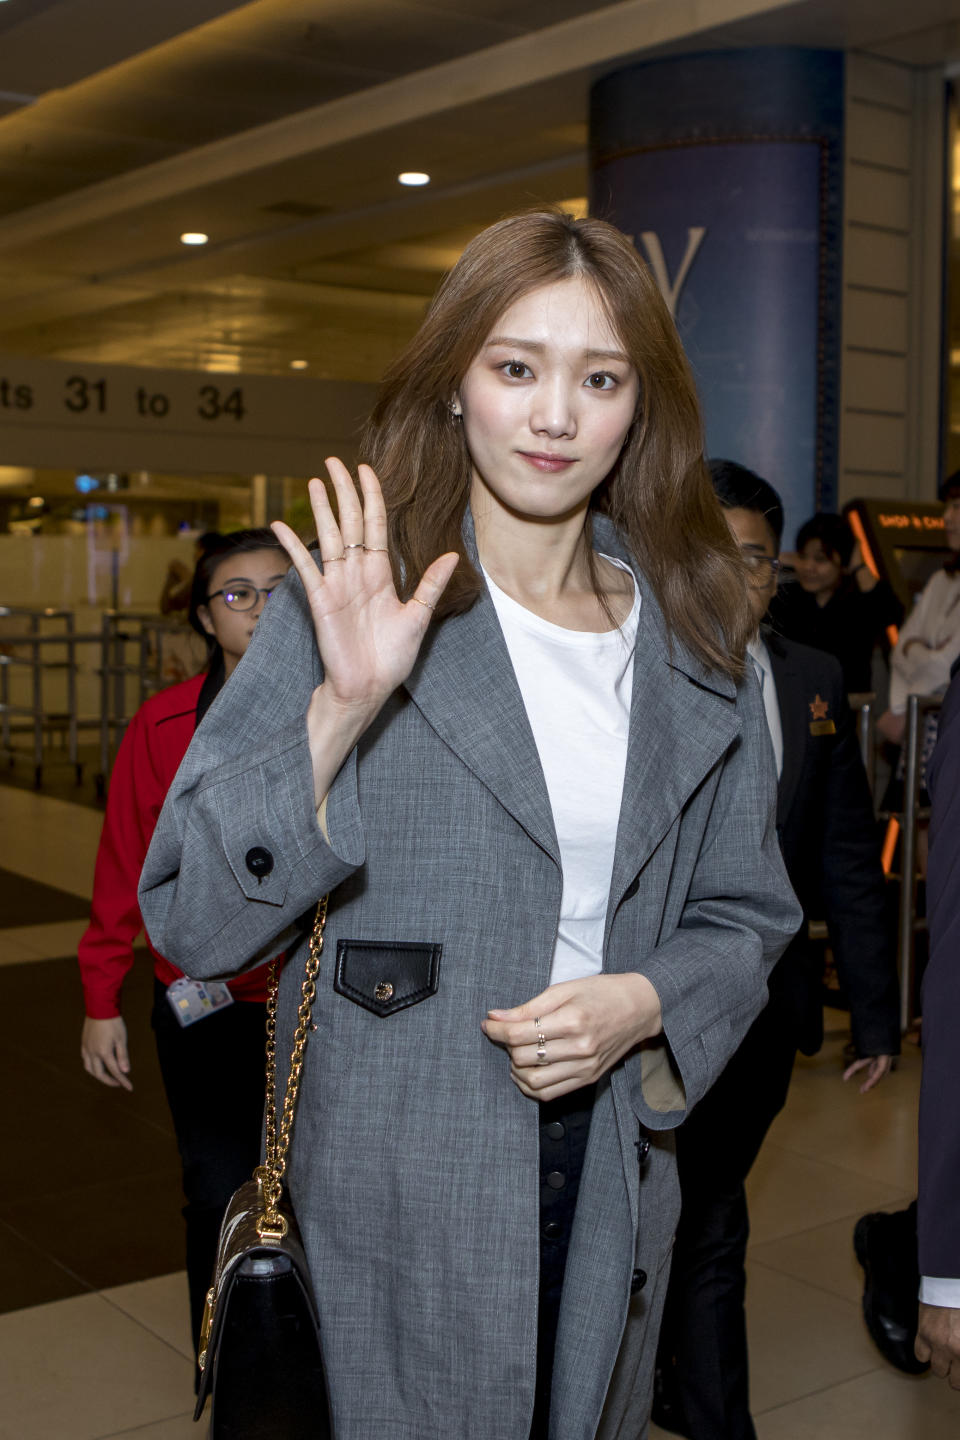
top-left (78, 530), bottom-right (289, 1376)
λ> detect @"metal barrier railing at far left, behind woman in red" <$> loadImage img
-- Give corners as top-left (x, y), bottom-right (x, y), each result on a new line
top-left (0, 605), bottom-right (192, 795)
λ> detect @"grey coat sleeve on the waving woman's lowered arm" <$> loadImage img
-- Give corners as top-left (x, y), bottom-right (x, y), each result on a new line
top-left (625, 680), bottom-right (803, 1129)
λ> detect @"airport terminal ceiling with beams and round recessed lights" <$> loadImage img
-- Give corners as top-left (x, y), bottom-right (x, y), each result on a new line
top-left (0, 0), bottom-right (960, 518)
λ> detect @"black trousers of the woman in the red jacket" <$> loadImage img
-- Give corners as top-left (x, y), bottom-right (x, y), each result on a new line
top-left (153, 981), bottom-right (266, 1351)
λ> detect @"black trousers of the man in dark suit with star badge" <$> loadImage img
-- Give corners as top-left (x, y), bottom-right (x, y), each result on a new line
top-left (656, 1001), bottom-right (797, 1440)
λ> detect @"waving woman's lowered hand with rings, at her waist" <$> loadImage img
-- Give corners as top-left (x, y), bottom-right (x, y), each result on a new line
top-left (481, 973), bottom-right (664, 1100)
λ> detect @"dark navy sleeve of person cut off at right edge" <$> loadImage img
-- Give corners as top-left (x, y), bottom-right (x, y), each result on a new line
top-left (917, 668), bottom-right (960, 1279)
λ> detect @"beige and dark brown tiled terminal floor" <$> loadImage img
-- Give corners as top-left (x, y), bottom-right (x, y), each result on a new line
top-left (0, 788), bottom-right (960, 1440)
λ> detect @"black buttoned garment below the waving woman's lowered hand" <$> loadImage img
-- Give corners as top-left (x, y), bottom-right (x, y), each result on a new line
top-left (530, 1086), bottom-right (596, 1440)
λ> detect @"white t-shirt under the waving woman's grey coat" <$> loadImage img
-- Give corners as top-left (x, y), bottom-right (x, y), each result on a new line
top-left (485, 560), bottom-right (640, 985)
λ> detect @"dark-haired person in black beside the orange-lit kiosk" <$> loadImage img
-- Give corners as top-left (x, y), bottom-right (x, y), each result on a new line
top-left (770, 513), bottom-right (904, 696)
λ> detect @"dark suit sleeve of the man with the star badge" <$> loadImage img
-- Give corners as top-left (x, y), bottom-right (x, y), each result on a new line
top-left (820, 657), bottom-right (900, 1056)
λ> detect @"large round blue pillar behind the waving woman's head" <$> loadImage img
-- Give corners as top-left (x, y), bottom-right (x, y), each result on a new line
top-left (590, 48), bottom-right (843, 543)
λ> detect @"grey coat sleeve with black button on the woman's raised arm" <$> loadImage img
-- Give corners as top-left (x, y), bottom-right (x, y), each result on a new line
top-left (140, 572), bottom-right (364, 979)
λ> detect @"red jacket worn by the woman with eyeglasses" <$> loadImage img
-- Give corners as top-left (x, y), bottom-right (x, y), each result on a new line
top-left (78, 675), bottom-right (266, 1020)
